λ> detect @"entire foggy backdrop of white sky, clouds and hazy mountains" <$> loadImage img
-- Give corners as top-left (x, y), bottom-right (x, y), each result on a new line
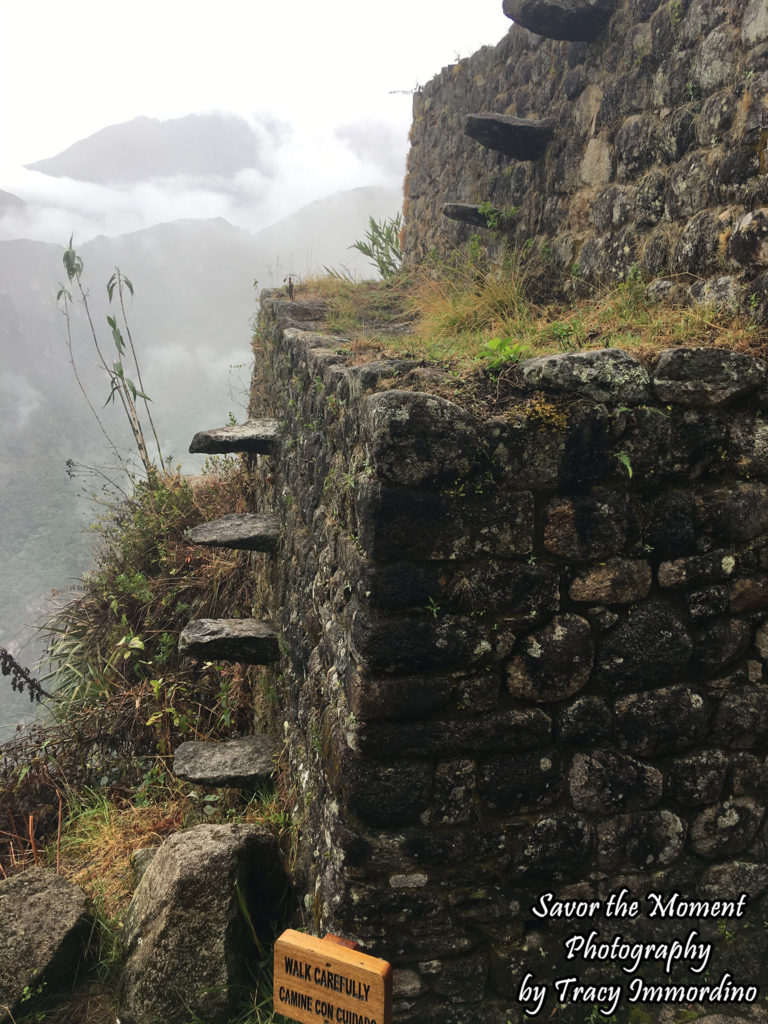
top-left (0, 0), bottom-right (518, 739)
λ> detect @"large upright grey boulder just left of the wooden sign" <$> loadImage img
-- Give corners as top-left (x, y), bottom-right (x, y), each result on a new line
top-left (120, 824), bottom-right (285, 1024)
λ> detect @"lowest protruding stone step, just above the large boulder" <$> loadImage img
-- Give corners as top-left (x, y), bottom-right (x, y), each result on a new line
top-left (173, 736), bottom-right (280, 788)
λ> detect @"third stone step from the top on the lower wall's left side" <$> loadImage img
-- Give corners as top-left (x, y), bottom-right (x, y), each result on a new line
top-left (178, 618), bottom-right (280, 665)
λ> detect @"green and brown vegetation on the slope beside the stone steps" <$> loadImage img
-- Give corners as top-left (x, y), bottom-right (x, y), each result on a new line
top-left (0, 458), bottom-right (292, 1024)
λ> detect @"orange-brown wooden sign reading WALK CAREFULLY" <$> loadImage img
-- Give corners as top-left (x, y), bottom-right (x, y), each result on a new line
top-left (273, 928), bottom-right (392, 1024)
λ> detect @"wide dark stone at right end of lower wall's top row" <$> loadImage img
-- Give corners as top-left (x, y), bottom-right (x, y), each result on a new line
top-left (653, 348), bottom-right (768, 407)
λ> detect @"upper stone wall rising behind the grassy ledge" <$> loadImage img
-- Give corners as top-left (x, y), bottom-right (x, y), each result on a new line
top-left (404, 0), bottom-right (768, 316)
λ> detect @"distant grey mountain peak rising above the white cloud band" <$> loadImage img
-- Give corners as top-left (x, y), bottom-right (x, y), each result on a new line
top-left (26, 114), bottom-right (288, 184)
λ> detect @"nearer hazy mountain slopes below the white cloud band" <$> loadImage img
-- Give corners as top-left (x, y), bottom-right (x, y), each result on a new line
top-left (0, 188), bottom-right (400, 733)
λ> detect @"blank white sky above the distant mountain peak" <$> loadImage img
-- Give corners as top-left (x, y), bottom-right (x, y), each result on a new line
top-left (0, 0), bottom-right (511, 165)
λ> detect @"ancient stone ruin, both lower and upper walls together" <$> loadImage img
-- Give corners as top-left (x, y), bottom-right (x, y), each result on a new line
top-left (163, 0), bottom-right (768, 1024)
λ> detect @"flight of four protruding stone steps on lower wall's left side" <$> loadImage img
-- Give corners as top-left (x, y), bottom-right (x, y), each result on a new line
top-left (173, 420), bottom-right (280, 788)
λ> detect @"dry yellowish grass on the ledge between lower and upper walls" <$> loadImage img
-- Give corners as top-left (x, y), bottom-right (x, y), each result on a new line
top-left (290, 259), bottom-right (768, 375)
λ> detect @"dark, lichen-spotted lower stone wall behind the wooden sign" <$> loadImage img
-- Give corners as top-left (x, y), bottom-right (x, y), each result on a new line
top-left (252, 293), bottom-right (768, 1024)
